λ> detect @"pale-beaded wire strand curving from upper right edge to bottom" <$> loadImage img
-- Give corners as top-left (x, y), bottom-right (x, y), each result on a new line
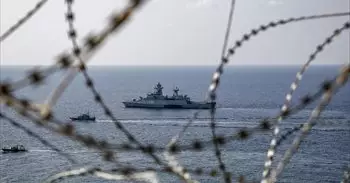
top-left (262, 22), bottom-right (350, 182)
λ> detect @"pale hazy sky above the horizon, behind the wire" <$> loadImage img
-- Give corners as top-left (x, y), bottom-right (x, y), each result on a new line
top-left (0, 0), bottom-right (350, 65)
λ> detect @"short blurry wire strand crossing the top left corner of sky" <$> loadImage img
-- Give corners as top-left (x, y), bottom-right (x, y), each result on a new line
top-left (0, 0), bottom-right (47, 42)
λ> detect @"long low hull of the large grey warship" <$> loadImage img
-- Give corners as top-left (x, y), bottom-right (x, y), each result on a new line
top-left (123, 102), bottom-right (211, 109)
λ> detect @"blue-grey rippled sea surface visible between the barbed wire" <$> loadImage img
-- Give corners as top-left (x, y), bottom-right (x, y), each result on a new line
top-left (0, 66), bottom-right (350, 183)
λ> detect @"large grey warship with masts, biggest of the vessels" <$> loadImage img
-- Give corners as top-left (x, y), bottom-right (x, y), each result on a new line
top-left (122, 82), bottom-right (215, 109)
